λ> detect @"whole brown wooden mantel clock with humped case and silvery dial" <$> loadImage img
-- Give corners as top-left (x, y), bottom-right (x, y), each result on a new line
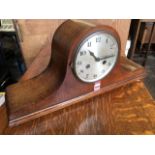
top-left (6, 20), bottom-right (145, 126)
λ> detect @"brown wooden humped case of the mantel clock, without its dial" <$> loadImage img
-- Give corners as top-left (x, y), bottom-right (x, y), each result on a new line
top-left (6, 20), bottom-right (145, 126)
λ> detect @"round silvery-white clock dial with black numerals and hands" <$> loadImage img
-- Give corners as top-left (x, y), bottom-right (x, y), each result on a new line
top-left (74, 31), bottom-right (119, 82)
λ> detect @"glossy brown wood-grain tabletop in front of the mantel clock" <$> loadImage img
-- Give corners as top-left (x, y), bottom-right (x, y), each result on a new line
top-left (4, 81), bottom-right (155, 134)
